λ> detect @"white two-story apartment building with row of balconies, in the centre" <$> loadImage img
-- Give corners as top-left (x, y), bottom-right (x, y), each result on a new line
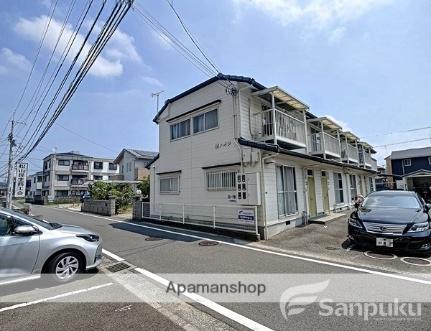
top-left (148, 74), bottom-right (377, 238)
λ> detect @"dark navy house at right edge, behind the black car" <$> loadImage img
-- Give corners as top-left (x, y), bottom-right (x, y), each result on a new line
top-left (386, 147), bottom-right (431, 201)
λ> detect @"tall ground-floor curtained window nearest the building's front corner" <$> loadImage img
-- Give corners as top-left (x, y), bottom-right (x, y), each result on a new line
top-left (276, 166), bottom-right (298, 217)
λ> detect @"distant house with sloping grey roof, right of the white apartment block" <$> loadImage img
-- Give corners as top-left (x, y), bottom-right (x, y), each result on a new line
top-left (114, 148), bottom-right (157, 181)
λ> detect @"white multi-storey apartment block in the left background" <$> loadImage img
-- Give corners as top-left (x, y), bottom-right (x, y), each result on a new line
top-left (42, 152), bottom-right (119, 199)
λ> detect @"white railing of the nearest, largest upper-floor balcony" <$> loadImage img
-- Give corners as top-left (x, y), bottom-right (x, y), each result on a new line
top-left (255, 109), bottom-right (305, 147)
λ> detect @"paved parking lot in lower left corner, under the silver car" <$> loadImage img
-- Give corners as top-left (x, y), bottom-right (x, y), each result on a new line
top-left (0, 256), bottom-right (236, 330)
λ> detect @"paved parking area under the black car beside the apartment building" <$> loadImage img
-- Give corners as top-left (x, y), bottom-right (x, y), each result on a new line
top-left (250, 217), bottom-right (431, 278)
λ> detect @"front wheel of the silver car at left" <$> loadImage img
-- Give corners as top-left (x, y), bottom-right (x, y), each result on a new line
top-left (48, 252), bottom-right (82, 283)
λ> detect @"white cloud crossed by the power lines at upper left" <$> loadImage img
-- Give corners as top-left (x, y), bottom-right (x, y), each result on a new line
top-left (15, 15), bottom-right (141, 77)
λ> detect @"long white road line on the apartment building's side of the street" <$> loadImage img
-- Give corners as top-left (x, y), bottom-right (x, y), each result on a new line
top-left (55, 207), bottom-right (431, 285)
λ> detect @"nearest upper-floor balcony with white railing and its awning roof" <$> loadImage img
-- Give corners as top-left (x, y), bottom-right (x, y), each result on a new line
top-left (252, 86), bottom-right (308, 149)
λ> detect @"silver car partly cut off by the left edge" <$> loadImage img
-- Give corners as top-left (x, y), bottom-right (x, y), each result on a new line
top-left (0, 208), bottom-right (102, 283)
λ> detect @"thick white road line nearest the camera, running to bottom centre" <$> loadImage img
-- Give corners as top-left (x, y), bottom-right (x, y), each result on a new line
top-left (104, 250), bottom-right (272, 331)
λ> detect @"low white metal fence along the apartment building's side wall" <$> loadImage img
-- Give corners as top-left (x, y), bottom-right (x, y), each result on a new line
top-left (134, 201), bottom-right (258, 234)
